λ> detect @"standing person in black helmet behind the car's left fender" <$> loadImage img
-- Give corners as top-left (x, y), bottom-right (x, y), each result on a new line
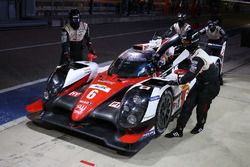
top-left (60, 9), bottom-right (95, 64)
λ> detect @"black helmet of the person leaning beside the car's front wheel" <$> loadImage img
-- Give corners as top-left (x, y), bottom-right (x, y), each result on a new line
top-left (181, 29), bottom-right (200, 52)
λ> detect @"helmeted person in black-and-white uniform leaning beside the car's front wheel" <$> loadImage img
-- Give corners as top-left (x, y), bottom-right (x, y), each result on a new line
top-left (165, 30), bottom-right (220, 138)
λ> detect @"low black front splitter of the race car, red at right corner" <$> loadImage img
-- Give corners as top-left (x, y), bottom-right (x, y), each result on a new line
top-left (28, 111), bottom-right (155, 153)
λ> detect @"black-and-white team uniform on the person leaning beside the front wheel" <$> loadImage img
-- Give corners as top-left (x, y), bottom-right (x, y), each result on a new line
top-left (177, 49), bottom-right (220, 133)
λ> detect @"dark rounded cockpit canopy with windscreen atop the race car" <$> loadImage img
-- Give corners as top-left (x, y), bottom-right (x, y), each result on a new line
top-left (108, 48), bottom-right (155, 78)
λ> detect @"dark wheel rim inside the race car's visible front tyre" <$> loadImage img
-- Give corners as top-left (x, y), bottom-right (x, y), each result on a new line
top-left (156, 92), bottom-right (172, 133)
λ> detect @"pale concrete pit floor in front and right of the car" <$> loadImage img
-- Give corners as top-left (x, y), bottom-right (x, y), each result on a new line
top-left (0, 37), bottom-right (250, 167)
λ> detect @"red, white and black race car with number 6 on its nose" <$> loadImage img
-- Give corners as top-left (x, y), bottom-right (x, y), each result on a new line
top-left (26, 35), bottom-right (213, 153)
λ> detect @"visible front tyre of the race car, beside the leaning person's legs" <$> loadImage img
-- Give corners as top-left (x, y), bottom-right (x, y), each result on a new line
top-left (155, 90), bottom-right (173, 136)
